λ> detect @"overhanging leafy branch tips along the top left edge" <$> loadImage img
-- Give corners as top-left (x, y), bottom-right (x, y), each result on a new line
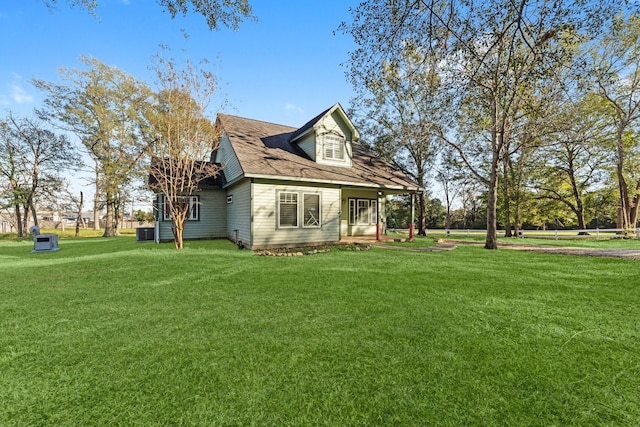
top-left (42, 0), bottom-right (255, 30)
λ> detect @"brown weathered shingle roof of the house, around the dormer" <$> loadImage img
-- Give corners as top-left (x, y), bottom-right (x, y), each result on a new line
top-left (218, 110), bottom-right (420, 191)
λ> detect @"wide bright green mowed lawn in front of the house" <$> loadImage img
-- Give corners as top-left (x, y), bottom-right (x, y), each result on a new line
top-left (0, 236), bottom-right (640, 426)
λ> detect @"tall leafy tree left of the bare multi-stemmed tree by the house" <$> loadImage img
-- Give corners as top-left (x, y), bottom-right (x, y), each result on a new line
top-left (34, 56), bottom-right (152, 237)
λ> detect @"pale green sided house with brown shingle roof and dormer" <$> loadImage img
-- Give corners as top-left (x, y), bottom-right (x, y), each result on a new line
top-left (156, 104), bottom-right (422, 249)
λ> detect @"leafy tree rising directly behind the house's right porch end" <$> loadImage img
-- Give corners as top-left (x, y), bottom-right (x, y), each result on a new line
top-left (348, 41), bottom-right (440, 235)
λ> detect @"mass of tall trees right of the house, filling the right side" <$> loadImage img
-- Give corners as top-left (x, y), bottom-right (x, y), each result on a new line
top-left (341, 0), bottom-right (640, 249)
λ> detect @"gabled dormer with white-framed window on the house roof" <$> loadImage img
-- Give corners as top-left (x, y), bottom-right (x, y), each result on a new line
top-left (290, 104), bottom-right (360, 167)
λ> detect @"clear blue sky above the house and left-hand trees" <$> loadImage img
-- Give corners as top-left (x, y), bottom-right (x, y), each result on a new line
top-left (0, 0), bottom-right (358, 206)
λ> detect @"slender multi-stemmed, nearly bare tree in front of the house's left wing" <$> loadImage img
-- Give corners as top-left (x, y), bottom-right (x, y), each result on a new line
top-left (147, 52), bottom-right (219, 250)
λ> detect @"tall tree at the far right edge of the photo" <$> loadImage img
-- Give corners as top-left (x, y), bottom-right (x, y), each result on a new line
top-left (590, 14), bottom-right (640, 234)
